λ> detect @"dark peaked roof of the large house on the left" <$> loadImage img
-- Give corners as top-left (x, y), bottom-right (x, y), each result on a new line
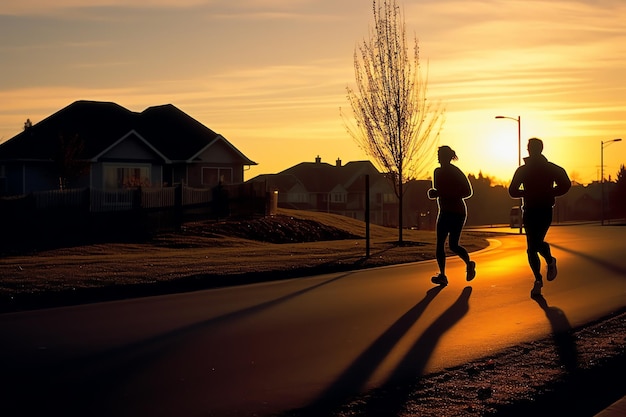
top-left (0, 100), bottom-right (256, 165)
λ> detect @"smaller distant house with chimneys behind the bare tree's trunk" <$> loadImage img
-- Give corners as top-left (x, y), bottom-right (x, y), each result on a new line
top-left (248, 156), bottom-right (398, 225)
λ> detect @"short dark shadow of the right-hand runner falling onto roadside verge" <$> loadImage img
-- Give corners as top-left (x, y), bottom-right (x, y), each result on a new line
top-left (533, 295), bottom-right (578, 372)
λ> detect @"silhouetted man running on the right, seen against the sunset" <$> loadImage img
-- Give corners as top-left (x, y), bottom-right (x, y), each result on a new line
top-left (509, 138), bottom-right (572, 297)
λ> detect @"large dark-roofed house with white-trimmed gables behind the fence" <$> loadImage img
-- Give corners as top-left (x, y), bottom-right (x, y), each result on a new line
top-left (0, 101), bottom-right (256, 196)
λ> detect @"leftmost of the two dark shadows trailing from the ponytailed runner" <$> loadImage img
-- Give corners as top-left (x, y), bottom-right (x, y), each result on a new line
top-left (303, 287), bottom-right (443, 415)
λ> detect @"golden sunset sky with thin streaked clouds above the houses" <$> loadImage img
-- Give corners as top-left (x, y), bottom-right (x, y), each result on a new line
top-left (0, 0), bottom-right (626, 184)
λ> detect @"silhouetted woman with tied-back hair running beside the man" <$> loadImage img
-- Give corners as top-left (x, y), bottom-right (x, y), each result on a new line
top-left (428, 146), bottom-right (476, 286)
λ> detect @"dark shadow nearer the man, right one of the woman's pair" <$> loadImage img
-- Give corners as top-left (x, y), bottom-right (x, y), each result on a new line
top-left (364, 286), bottom-right (472, 416)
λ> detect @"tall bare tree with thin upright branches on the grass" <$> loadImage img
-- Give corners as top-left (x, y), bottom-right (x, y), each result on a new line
top-left (342, 0), bottom-right (444, 244)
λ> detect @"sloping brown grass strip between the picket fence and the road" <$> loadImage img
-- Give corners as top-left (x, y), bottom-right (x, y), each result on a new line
top-left (0, 209), bottom-right (488, 310)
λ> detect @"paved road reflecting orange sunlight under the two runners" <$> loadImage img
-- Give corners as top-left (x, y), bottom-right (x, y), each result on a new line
top-left (0, 225), bottom-right (626, 417)
